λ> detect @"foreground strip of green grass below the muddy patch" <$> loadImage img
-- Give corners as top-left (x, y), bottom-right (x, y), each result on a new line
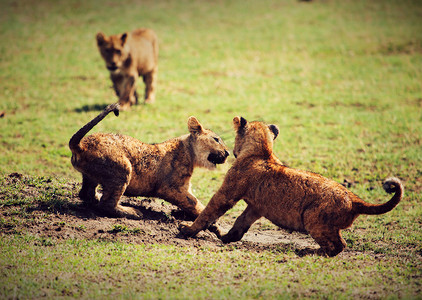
top-left (0, 236), bottom-right (421, 299)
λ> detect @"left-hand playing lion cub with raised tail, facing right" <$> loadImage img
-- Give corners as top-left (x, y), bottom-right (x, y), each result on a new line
top-left (69, 104), bottom-right (229, 223)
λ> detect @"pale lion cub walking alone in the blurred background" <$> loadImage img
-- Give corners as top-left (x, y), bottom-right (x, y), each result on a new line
top-left (97, 29), bottom-right (158, 109)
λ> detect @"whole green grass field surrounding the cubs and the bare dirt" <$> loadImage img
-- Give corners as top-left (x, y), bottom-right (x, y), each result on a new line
top-left (0, 0), bottom-right (422, 298)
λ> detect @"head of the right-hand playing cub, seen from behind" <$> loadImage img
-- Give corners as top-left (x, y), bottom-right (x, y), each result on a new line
top-left (233, 117), bottom-right (279, 158)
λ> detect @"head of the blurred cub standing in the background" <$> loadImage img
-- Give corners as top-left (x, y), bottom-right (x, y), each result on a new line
top-left (97, 32), bottom-right (129, 72)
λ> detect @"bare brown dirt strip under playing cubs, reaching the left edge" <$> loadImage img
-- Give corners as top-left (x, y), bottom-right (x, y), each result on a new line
top-left (0, 173), bottom-right (319, 255)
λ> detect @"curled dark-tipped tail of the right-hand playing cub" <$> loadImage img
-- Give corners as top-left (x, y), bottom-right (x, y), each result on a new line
top-left (353, 177), bottom-right (404, 215)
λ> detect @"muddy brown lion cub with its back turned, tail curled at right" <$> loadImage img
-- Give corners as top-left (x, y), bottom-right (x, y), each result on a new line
top-left (179, 117), bottom-right (403, 256)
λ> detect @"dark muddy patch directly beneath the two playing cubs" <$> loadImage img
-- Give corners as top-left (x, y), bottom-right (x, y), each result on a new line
top-left (0, 198), bottom-right (318, 254)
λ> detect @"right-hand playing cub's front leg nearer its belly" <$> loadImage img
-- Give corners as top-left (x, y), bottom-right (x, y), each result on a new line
top-left (221, 205), bottom-right (261, 243)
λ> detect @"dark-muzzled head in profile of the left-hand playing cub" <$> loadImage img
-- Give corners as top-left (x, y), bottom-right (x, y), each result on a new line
top-left (188, 117), bottom-right (230, 170)
